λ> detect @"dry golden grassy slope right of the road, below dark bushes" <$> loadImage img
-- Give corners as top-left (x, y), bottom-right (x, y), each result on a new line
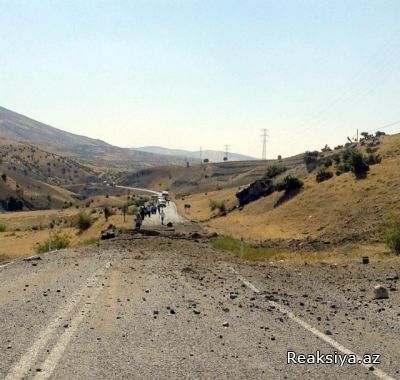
top-left (176, 135), bottom-right (400, 243)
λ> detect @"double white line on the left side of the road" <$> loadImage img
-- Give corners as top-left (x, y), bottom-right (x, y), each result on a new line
top-left (5, 263), bottom-right (110, 380)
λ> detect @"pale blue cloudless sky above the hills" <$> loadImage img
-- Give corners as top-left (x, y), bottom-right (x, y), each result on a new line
top-left (0, 0), bottom-right (400, 158)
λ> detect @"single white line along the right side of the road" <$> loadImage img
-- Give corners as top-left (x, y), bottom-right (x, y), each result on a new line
top-left (230, 267), bottom-right (395, 380)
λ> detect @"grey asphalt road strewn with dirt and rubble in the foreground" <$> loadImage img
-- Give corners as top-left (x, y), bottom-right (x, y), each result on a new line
top-left (0, 233), bottom-right (400, 380)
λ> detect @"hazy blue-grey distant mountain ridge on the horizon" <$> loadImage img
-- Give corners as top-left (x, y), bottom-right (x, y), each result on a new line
top-left (135, 146), bottom-right (256, 162)
